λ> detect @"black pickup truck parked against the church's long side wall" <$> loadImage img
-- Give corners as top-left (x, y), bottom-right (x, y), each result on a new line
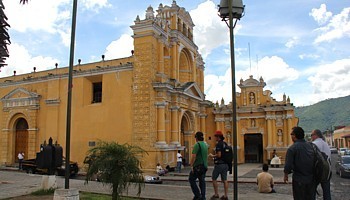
top-left (22, 159), bottom-right (79, 176)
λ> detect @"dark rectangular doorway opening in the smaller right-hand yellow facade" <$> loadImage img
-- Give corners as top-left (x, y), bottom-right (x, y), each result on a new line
top-left (244, 133), bottom-right (263, 163)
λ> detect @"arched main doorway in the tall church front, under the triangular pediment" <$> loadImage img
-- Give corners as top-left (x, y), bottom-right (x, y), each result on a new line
top-left (181, 112), bottom-right (194, 166)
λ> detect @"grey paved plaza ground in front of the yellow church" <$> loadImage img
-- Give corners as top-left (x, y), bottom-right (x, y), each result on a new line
top-left (0, 164), bottom-right (293, 200)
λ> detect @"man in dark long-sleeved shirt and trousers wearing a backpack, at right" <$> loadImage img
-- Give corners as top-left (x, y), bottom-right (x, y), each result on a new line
top-left (284, 127), bottom-right (316, 200)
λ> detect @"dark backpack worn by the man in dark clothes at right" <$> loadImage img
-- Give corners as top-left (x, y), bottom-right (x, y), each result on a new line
top-left (310, 143), bottom-right (332, 183)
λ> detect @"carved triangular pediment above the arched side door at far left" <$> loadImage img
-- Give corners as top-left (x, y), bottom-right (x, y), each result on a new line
top-left (1, 88), bottom-right (41, 109)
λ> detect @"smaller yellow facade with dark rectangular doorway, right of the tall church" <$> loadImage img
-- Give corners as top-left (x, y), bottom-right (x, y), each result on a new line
top-left (207, 76), bottom-right (298, 163)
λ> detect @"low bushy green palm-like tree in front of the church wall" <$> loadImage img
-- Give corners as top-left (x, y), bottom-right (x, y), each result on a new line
top-left (84, 141), bottom-right (146, 200)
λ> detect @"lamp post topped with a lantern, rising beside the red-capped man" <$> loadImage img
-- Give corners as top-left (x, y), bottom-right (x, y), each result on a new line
top-left (219, 0), bottom-right (244, 200)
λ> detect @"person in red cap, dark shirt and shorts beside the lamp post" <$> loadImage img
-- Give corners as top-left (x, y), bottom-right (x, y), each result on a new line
top-left (210, 130), bottom-right (228, 200)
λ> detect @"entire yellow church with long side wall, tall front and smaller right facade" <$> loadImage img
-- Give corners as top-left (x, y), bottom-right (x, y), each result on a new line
top-left (0, 1), bottom-right (297, 169)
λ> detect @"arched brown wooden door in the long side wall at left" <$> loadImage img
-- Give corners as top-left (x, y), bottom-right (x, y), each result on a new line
top-left (14, 118), bottom-right (28, 162)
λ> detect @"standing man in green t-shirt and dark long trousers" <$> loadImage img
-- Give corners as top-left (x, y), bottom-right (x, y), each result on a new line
top-left (188, 132), bottom-right (208, 200)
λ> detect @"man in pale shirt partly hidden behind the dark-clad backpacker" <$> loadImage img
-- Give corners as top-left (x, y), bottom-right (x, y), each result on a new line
top-left (311, 129), bottom-right (331, 200)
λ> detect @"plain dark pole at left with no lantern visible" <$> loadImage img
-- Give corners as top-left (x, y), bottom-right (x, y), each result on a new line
top-left (64, 0), bottom-right (78, 189)
